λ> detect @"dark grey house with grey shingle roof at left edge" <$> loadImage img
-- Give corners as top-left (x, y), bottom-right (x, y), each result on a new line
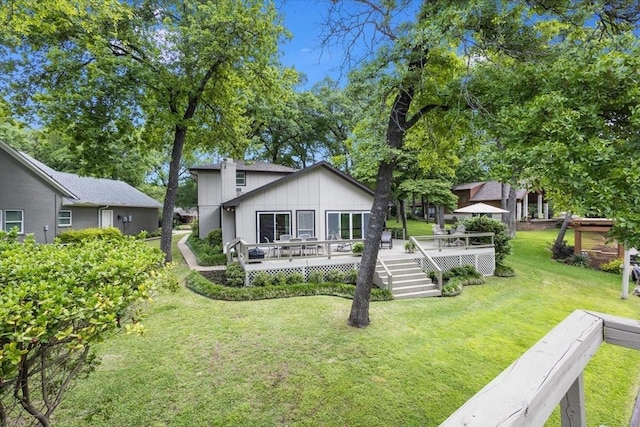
top-left (0, 141), bottom-right (162, 243)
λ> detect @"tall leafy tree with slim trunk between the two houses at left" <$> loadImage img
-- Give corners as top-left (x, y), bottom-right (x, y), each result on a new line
top-left (4, 0), bottom-right (291, 261)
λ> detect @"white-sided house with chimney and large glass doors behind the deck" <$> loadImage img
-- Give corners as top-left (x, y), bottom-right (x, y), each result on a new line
top-left (191, 159), bottom-right (374, 247)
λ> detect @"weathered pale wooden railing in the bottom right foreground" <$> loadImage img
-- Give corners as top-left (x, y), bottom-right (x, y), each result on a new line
top-left (441, 310), bottom-right (640, 427)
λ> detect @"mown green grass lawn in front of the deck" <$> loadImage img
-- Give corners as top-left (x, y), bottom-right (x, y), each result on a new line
top-left (55, 231), bottom-right (640, 427)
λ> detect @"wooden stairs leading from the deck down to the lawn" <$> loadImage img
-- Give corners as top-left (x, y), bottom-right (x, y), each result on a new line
top-left (374, 259), bottom-right (441, 299)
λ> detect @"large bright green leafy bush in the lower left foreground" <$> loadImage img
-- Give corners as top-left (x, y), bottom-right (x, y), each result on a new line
top-left (0, 230), bottom-right (176, 425)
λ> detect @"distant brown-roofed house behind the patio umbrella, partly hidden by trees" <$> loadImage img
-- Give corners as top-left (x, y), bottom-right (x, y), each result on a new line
top-left (452, 181), bottom-right (549, 221)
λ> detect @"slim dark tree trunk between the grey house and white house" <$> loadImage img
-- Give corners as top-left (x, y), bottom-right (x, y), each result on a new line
top-left (160, 126), bottom-right (187, 262)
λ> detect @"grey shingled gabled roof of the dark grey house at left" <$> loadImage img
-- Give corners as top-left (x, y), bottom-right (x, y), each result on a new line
top-left (0, 141), bottom-right (162, 208)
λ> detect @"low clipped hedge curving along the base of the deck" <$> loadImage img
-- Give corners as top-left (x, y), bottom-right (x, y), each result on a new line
top-left (186, 271), bottom-right (393, 301)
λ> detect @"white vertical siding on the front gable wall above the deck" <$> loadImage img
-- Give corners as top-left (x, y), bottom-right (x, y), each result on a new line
top-left (236, 168), bottom-right (373, 243)
